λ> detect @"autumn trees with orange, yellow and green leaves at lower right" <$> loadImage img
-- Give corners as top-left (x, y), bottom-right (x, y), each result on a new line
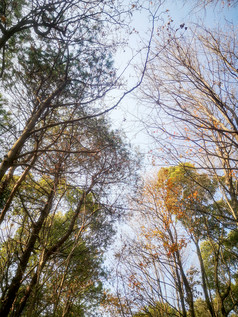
top-left (113, 164), bottom-right (238, 316)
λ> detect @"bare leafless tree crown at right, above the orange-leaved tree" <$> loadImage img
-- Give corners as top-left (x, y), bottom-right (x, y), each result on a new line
top-left (141, 25), bottom-right (238, 223)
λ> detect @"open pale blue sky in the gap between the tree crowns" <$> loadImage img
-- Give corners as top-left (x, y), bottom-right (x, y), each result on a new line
top-left (110, 0), bottom-right (238, 170)
